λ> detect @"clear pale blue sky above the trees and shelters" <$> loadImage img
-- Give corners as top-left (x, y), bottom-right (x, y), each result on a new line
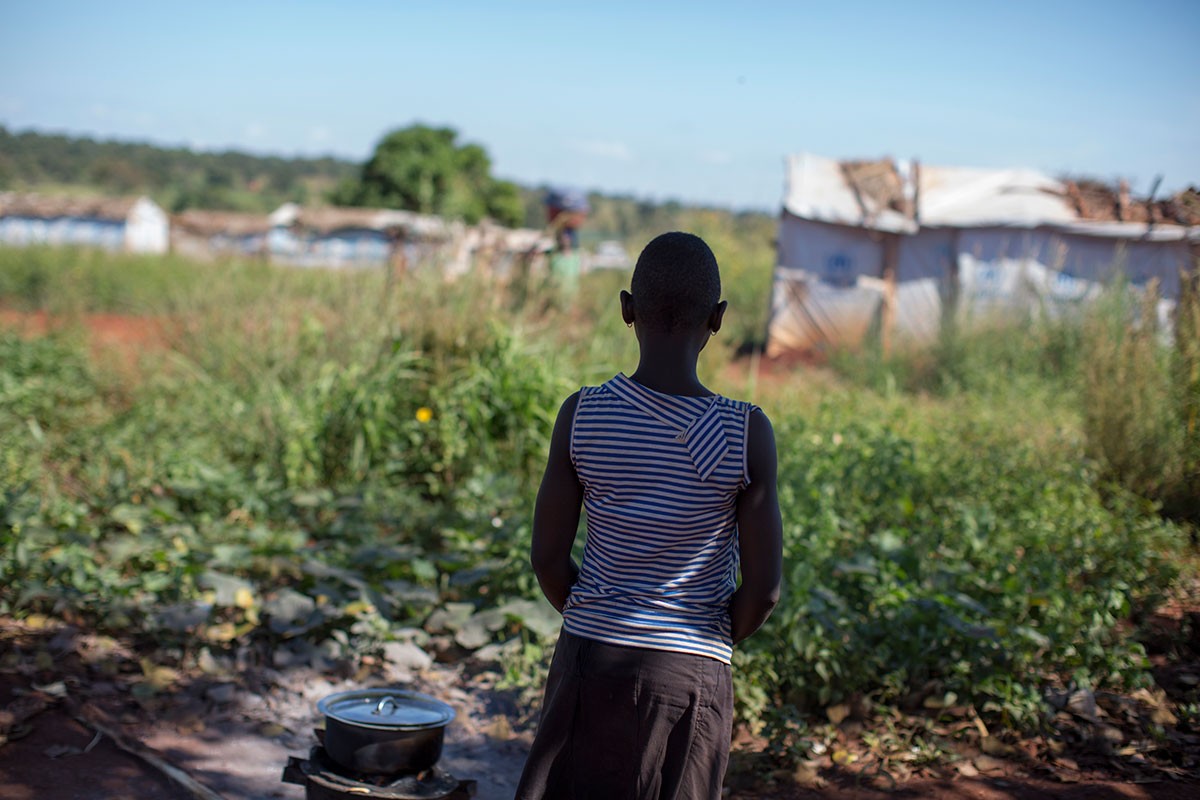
top-left (0, 0), bottom-right (1200, 210)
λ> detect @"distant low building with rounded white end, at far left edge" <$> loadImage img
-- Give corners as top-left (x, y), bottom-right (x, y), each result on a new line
top-left (0, 192), bottom-right (169, 253)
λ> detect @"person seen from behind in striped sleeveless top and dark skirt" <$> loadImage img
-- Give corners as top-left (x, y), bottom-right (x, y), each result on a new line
top-left (517, 227), bottom-right (782, 800)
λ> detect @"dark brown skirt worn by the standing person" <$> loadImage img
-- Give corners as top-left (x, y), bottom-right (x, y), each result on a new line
top-left (516, 631), bottom-right (733, 800)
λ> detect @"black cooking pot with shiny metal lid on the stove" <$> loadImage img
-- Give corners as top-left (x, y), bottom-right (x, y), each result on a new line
top-left (317, 688), bottom-right (455, 775)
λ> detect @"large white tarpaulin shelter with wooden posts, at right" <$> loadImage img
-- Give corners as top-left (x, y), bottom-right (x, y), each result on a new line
top-left (767, 154), bottom-right (1200, 356)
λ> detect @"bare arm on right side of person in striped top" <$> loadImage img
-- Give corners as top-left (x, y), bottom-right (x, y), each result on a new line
top-left (730, 409), bottom-right (784, 644)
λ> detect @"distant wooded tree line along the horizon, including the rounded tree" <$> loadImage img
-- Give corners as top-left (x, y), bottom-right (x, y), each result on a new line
top-left (0, 125), bottom-right (774, 251)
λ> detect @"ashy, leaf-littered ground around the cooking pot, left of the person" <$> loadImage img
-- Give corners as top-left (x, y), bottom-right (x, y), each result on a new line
top-left (0, 633), bottom-right (529, 800)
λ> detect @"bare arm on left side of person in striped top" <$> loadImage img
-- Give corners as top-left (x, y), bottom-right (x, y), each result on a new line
top-left (529, 392), bottom-right (583, 613)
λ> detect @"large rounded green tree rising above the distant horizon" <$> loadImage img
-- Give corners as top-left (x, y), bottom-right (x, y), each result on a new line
top-left (334, 125), bottom-right (524, 225)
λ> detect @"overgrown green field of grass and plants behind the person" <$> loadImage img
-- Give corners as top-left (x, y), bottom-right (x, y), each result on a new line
top-left (0, 249), bottom-right (1200, 777)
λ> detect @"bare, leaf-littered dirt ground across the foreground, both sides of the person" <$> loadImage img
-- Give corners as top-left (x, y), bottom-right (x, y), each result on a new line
top-left (0, 620), bottom-right (1200, 800)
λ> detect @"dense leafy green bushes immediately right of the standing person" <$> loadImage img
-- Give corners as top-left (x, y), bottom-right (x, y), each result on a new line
top-left (746, 410), bottom-right (1182, 724)
